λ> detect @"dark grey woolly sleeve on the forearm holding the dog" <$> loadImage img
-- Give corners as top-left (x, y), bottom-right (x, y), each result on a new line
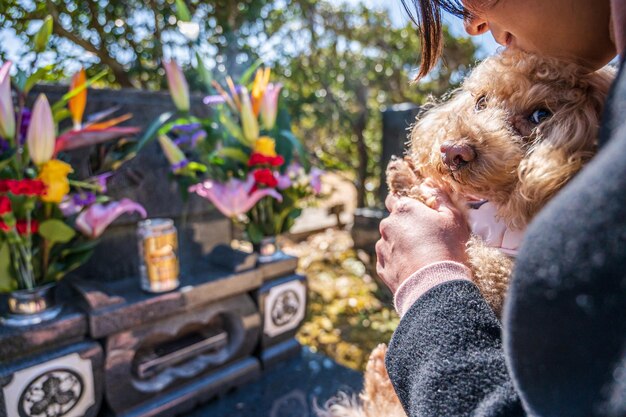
top-left (386, 280), bottom-right (525, 417)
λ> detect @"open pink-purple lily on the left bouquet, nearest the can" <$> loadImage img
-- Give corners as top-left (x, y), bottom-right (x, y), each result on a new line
top-left (76, 198), bottom-right (147, 239)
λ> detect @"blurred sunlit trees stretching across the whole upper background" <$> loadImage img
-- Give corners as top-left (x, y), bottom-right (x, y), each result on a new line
top-left (0, 0), bottom-right (476, 206)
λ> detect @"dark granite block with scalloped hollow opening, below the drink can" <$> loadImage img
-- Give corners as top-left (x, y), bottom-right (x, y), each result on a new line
top-left (105, 294), bottom-right (261, 414)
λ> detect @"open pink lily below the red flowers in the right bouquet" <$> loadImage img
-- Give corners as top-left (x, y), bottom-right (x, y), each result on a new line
top-left (189, 175), bottom-right (283, 218)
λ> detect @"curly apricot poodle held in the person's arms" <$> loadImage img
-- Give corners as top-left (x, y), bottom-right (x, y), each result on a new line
top-left (325, 51), bottom-right (614, 417)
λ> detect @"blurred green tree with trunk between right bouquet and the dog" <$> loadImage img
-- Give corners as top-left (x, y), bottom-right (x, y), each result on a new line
top-left (276, 0), bottom-right (476, 207)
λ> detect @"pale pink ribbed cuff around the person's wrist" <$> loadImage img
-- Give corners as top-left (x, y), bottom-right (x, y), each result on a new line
top-left (394, 261), bottom-right (472, 317)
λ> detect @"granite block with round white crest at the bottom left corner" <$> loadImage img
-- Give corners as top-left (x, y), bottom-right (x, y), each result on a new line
top-left (0, 342), bottom-right (104, 417)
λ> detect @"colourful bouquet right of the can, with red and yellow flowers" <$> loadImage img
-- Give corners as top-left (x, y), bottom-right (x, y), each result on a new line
top-left (158, 62), bottom-right (321, 250)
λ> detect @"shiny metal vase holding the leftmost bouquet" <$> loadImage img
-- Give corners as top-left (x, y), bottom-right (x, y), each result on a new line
top-left (2, 282), bottom-right (61, 326)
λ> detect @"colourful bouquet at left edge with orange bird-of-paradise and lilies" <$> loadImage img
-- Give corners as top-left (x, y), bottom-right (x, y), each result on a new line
top-left (0, 58), bottom-right (146, 320)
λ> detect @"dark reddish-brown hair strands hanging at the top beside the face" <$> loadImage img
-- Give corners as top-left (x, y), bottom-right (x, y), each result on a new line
top-left (401, 0), bottom-right (498, 80)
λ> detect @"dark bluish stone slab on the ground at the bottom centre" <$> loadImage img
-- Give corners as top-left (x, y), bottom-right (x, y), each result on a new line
top-left (185, 348), bottom-right (363, 417)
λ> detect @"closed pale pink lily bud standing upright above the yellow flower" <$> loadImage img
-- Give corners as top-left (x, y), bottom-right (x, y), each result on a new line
top-left (26, 94), bottom-right (56, 165)
